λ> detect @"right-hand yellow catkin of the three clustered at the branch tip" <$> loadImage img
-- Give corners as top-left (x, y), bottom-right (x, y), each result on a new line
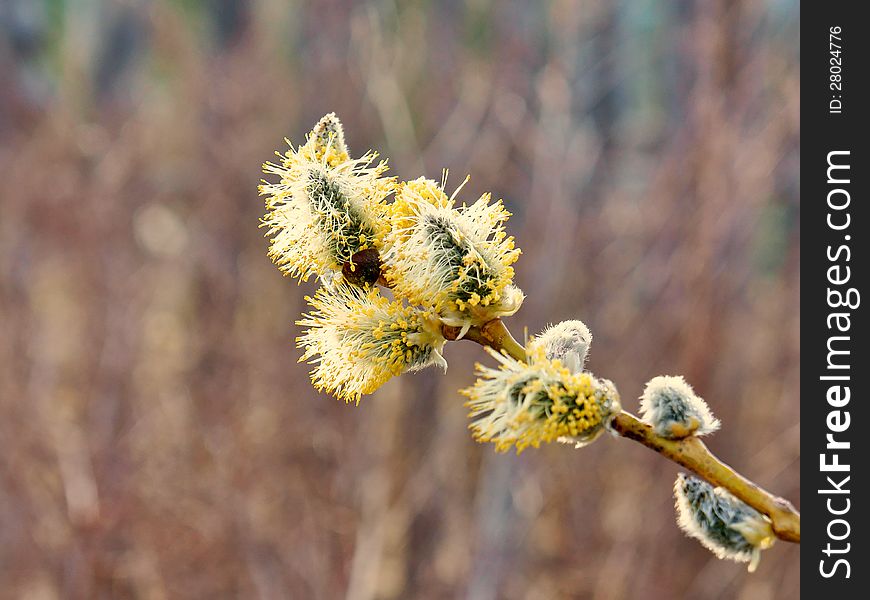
top-left (385, 178), bottom-right (523, 327)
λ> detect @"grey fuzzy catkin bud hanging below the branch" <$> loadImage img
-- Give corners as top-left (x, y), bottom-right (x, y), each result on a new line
top-left (674, 473), bottom-right (776, 573)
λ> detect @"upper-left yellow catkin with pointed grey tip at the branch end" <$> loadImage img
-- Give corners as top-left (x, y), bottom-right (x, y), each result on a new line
top-left (259, 114), bottom-right (394, 283)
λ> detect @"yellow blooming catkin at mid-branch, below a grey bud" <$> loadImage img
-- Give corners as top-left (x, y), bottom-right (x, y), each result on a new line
top-left (462, 347), bottom-right (620, 453)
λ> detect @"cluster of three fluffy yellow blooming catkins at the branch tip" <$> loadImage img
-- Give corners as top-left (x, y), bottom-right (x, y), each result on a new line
top-left (260, 114), bottom-right (523, 402)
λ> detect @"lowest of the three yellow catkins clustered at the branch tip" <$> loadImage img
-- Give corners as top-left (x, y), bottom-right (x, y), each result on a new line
top-left (297, 283), bottom-right (447, 403)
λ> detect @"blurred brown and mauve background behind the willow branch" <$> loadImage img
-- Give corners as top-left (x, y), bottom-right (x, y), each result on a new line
top-left (0, 0), bottom-right (800, 600)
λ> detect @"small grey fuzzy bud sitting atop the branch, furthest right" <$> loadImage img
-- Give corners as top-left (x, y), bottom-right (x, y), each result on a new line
top-left (640, 375), bottom-right (719, 439)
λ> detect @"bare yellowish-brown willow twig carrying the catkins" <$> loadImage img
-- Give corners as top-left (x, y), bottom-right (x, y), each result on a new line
top-left (443, 319), bottom-right (801, 543)
